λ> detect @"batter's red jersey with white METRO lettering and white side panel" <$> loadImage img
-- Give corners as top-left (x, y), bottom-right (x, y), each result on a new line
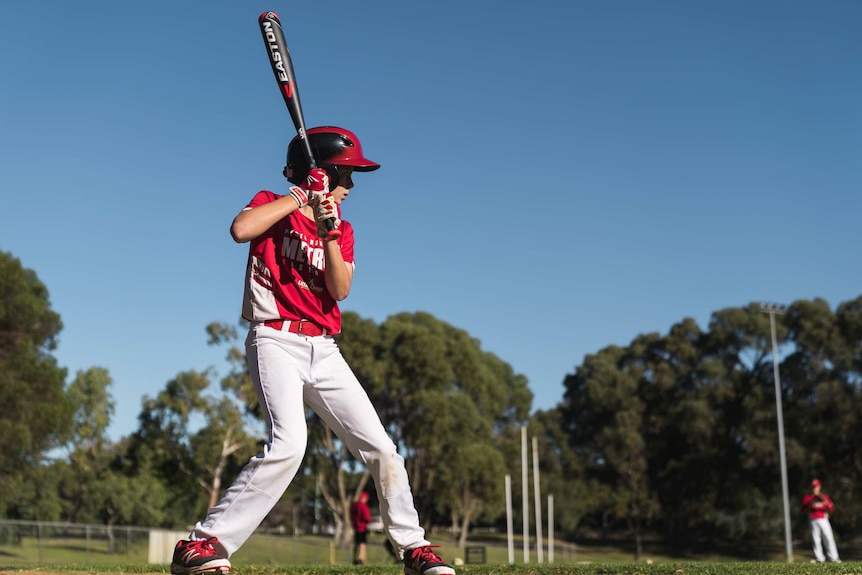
top-left (242, 190), bottom-right (354, 335)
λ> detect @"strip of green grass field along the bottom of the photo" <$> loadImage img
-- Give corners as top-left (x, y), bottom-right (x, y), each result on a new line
top-left (0, 535), bottom-right (862, 575)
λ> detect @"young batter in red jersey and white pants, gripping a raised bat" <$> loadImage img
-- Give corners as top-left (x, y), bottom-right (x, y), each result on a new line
top-left (171, 126), bottom-right (455, 575)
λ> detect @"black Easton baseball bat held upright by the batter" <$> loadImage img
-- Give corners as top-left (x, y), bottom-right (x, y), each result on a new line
top-left (257, 12), bottom-right (341, 239)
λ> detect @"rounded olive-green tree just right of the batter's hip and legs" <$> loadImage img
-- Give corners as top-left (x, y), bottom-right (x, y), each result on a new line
top-left (341, 312), bottom-right (532, 543)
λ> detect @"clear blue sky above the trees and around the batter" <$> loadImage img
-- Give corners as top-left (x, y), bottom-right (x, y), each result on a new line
top-left (0, 0), bottom-right (862, 439)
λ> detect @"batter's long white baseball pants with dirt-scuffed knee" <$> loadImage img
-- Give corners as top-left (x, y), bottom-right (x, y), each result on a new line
top-left (190, 324), bottom-right (429, 557)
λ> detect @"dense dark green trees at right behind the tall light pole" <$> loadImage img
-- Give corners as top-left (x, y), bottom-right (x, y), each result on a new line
top-left (558, 298), bottom-right (862, 541)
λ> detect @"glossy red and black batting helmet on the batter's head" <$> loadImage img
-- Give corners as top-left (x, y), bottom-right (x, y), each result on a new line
top-left (284, 126), bottom-right (380, 188)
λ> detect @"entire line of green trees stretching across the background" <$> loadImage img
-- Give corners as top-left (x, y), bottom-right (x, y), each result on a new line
top-left (0, 251), bottom-right (862, 556)
